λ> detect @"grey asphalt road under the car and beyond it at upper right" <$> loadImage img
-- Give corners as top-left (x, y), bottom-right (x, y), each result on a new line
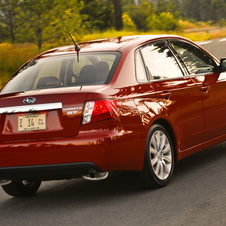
top-left (0, 39), bottom-right (226, 226)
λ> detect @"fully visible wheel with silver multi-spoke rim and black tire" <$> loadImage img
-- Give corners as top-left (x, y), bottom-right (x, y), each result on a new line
top-left (142, 124), bottom-right (175, 189)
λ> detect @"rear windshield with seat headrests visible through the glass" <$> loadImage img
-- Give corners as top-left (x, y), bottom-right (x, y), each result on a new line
top-left (1, 52), bottom-right (121, 94)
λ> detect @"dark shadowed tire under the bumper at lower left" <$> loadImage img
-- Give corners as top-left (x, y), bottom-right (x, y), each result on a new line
top-left (2, 180), bottom-right (41, 197)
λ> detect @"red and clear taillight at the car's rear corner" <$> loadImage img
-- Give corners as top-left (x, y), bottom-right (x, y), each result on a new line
top-left (82, 100), bottom-right (118, 124)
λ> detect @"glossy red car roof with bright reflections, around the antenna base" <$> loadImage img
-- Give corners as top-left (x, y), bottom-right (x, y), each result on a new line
top-left (35, 35), bottom-right (187, 59)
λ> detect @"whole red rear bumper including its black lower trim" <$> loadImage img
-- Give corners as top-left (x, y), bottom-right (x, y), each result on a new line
top-left (0, 126), bottom-right (145, 180)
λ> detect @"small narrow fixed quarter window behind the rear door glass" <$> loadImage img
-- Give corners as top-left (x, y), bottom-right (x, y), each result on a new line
top-left (135, 51), bottom-right (148, 82)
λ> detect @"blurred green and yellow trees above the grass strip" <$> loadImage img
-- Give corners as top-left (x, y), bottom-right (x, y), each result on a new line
top-left (0, 0), bottom-right (226, 49)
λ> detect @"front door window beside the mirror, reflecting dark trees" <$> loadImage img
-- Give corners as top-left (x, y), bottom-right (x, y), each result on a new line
top-left (170, 40), bottom-right (216, 74)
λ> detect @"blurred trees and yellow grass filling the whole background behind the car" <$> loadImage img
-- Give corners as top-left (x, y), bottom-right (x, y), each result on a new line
top-left (0, 0), bottom-right (226, 87)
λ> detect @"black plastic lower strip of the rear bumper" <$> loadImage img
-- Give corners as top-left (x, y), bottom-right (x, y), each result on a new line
top-left (0, 162), bottom-right (101, 181)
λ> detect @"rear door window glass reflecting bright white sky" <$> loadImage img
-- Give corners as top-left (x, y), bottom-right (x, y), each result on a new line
top-left (141, 41), bottom-right (183, 80)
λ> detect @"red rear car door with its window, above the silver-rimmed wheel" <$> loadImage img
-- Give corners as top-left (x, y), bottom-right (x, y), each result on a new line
top-left (140, 40), bottom-right (204, 151)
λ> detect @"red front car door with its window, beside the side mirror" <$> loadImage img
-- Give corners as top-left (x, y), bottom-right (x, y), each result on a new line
top-left (170, 40), bottom-right (226, 141)
